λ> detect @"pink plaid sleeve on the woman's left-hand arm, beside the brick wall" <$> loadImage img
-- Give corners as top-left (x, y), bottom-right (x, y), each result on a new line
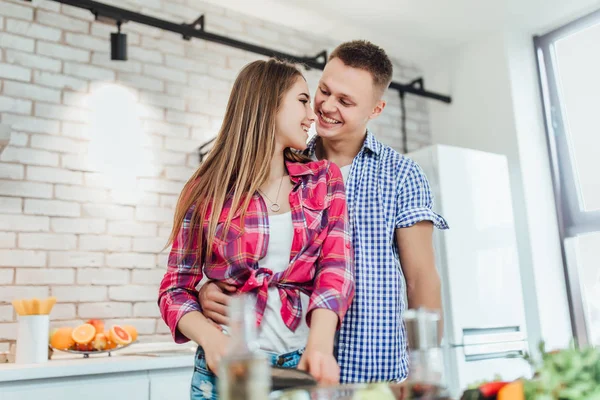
top-left (158, 207), bottom-right (203, 343)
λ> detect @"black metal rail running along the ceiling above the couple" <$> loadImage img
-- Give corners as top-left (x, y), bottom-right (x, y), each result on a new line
top-left (24, 0), bottom-right (452, 161)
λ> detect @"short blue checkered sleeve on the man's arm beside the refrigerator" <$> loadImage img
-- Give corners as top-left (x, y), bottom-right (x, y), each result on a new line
top-left (395, 162), bottom-right (448, 229)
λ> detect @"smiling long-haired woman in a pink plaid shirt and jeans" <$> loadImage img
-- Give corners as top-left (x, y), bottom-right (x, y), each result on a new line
top-left (159, 60), bottom-right (354, 399)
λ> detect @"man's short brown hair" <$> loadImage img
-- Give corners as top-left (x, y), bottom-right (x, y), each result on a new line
top-left (328, 40), bottom-right (393, 93)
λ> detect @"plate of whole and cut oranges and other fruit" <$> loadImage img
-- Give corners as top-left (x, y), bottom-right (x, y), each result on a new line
top-left (49, 319), bottom-right (138, 358)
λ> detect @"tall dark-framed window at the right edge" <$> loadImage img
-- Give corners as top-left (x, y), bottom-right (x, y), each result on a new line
top-left (535, 10), bottom-right (600, 346)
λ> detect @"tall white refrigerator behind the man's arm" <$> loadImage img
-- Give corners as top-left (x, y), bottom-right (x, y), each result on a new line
top-left (407, 145), bottom-right (531, 398)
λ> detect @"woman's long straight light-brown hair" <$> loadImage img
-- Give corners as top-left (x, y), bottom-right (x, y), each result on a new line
top-left (167, 59), bottom-right (307, 259)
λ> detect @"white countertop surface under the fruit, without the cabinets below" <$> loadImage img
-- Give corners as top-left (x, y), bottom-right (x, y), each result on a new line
top-left (0, 343), bottom-right (195, 382)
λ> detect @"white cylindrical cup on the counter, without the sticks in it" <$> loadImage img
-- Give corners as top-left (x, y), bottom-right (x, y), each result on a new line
top-left (15, 314), bottom-right (50, 364)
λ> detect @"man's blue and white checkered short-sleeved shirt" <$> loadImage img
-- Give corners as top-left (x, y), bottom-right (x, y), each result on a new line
top-left (307, 131), bottom-right (448, 383)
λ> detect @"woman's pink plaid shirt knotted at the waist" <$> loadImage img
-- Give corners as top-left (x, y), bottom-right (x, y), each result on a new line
top-left (158, 161), bottom-right (354, 343)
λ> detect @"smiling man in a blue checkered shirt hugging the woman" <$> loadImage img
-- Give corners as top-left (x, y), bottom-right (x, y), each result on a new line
top-left (200, 41), bottom-right (447, 383)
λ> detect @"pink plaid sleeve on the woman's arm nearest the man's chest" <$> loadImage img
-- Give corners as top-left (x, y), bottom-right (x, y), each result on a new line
top-left (306, 163), bottom-right (354, 329)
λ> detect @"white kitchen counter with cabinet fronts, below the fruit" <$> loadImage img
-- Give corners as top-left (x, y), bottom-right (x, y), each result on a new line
top-left (0, 343), bottom-right (195, 400)
